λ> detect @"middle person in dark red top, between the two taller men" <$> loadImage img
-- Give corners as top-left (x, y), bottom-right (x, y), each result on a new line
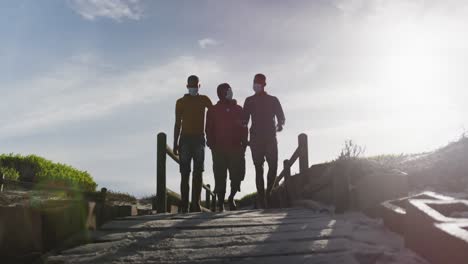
top-left (206, 83), bottom-right (248, 211)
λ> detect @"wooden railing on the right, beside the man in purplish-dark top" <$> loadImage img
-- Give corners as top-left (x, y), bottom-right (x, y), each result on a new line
top-left (273, 134), bottom-right (309, 188)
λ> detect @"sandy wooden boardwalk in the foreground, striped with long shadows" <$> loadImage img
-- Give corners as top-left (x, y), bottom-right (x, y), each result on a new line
top-left (48, 209), bottom-right (426, 264)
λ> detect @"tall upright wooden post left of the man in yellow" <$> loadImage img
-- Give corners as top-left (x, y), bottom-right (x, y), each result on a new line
top-left (156, 133), bottom-right (167, 214)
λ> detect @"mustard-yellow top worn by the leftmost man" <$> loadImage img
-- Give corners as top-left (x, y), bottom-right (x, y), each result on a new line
top-left (176, 95), bottom-right (213, 136)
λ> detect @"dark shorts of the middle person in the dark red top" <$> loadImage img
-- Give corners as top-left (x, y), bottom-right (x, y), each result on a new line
top-left (212, 150), bottom-right (245, 193)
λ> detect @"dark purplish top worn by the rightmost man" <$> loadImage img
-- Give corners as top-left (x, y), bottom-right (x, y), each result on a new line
top-left (244, 92), bottom-right (286, 141)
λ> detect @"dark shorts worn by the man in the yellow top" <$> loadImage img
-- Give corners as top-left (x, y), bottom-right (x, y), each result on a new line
top-left (179, 136), bottom-right (205, 174)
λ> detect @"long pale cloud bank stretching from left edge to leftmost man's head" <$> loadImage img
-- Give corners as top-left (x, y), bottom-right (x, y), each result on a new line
top-left (0, 54), bottom-right (220, 138)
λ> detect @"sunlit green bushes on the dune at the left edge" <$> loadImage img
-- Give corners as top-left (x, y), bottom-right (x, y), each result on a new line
top-left (0, 154), bottom-right (97, 191)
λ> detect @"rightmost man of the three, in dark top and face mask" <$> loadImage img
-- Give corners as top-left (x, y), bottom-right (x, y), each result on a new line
top-left (244, 74), bottom-right (286, 208)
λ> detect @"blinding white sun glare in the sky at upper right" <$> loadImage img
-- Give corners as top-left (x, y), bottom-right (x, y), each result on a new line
top-left (366, 21), bottom-right (458, 133)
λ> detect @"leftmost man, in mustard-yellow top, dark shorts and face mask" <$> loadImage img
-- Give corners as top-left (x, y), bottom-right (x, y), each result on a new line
top-left (174, 75), bottom-right (213, 213)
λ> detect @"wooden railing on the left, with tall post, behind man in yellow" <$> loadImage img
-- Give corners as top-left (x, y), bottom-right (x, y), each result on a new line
top-left (155, 133), bottom-right (216, 213)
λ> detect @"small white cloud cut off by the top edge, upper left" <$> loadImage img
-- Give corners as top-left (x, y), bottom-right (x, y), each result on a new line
top-left (69, 0), bottom-right (143, 21)
